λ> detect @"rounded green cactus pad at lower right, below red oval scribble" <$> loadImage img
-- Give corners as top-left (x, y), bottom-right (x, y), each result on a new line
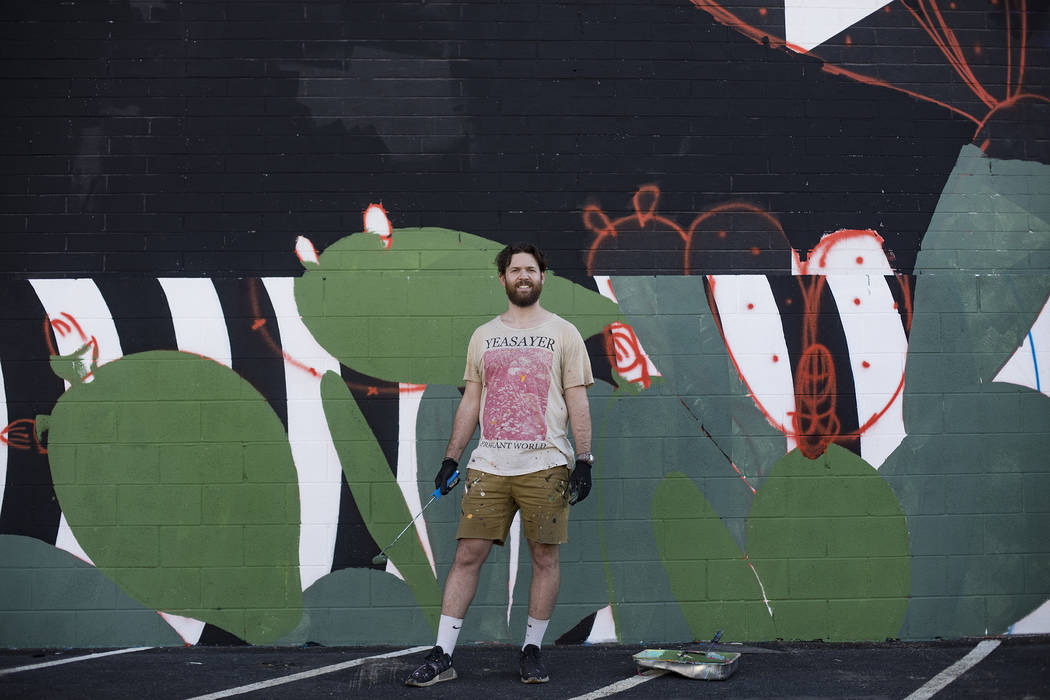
top-left (748, 444), bottom-right (911, 641)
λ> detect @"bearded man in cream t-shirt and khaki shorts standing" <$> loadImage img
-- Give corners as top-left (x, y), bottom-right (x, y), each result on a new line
top-left (405, 243), bottom-right (594, 686)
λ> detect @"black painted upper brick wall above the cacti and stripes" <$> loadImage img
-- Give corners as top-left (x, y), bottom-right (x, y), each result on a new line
top-left (6, 0), bottom-right (1033, 280)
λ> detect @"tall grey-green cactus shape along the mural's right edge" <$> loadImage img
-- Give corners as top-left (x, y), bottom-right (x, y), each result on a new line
top-left (879, 146), bottom-right (1050, 637)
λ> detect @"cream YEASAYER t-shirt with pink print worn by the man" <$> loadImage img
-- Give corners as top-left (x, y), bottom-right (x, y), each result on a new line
top-left (463, 314), bottom-right (594, 476)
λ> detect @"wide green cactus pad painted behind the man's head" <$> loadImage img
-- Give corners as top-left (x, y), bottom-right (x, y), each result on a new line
top-left (295, 228), bottom-right (616, 386)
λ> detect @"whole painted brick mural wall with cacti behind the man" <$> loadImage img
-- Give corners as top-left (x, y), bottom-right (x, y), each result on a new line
top-left (0, 0), bottom-right (1050, 648)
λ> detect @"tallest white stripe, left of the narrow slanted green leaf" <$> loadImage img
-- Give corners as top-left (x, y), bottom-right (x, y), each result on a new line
top-left (263, 277), bottom-right (342, 590)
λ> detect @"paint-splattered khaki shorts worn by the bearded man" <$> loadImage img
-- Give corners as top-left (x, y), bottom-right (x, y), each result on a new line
top-left (456, 466), bottom-right (569, 545)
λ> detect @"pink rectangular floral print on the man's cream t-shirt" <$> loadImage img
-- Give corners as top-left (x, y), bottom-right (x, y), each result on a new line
top-left (481, 347), bottom-right (554, 442)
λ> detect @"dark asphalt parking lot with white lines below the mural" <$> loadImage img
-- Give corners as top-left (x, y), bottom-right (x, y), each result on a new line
top-left (0, 636), bottom-right (1050, 700)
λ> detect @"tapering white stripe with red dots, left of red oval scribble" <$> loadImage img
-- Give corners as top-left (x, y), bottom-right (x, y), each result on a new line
top-left (709, 275), bottom-right (796, 452)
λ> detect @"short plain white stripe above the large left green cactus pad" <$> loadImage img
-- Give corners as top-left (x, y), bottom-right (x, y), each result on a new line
top-left (156, 277), bottom-right (233, 367)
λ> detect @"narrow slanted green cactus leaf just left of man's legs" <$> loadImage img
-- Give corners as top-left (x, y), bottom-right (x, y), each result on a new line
top-left (321, 372), bottom-right (441, 630)
